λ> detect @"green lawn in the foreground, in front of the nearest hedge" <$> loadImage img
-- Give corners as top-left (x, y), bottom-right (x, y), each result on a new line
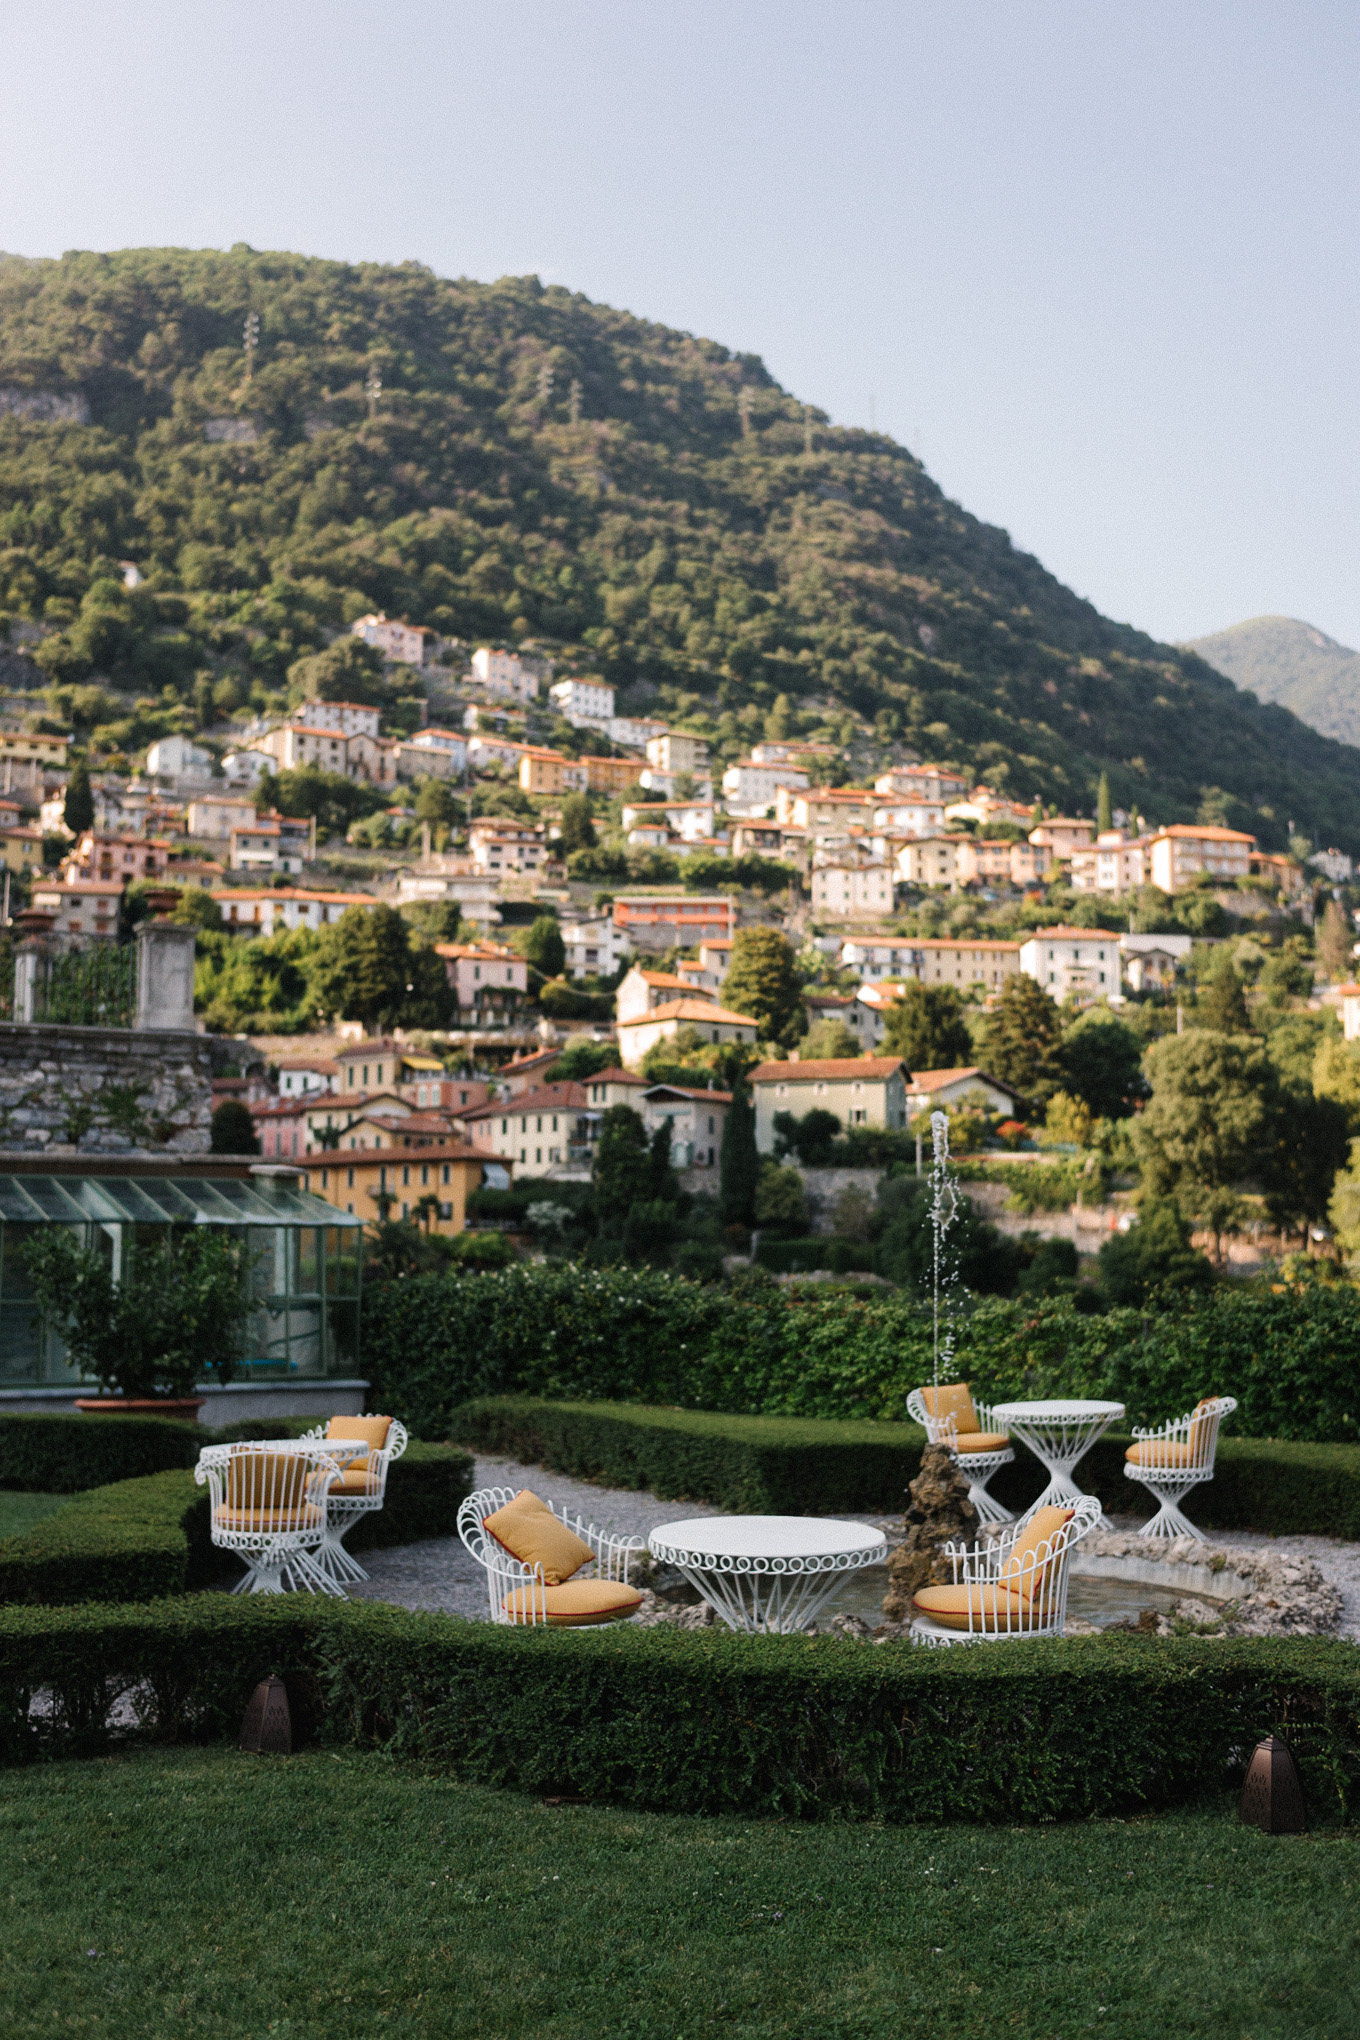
top-left (0, 1750), bottom-right (1360, 2040)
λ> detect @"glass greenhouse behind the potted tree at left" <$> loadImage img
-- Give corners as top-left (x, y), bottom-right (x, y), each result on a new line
top-left (0, 1169), bottom-right (363, 1389)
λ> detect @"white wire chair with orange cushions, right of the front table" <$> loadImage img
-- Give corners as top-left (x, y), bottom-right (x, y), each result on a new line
top-left (911, 1495), bottom-right (1101, 1644)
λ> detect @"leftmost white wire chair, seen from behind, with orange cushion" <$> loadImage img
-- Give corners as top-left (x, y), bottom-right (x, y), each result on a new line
top-left (194, 1440), bottom-right (345, 1599)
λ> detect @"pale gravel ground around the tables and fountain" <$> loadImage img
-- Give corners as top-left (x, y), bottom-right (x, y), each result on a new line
top-left (349, 1459), bottom-right (1360, 1642)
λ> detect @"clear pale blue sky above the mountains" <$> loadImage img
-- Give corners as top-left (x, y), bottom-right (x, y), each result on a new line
top-left (0, 0), bottom-right (1360, 645)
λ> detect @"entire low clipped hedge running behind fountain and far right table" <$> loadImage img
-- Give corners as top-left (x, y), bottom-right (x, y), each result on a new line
top-left (451, 1395), bottom-right (1360, 1540)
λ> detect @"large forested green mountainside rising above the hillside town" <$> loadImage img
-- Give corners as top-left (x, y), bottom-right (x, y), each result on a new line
top-left (0, 247), bottom-right (1360, 851)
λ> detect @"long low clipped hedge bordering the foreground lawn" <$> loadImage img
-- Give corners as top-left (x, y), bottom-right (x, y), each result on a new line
top-left (0, 1595), bottom-right (1360, 1824)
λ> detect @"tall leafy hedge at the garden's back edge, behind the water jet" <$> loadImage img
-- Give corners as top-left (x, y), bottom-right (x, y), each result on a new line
top-left (363, 1263), bottom-right (1360, 1442)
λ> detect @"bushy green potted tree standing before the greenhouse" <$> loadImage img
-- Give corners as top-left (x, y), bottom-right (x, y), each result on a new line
top-left (24, 1226), bottom-right (251, 1420)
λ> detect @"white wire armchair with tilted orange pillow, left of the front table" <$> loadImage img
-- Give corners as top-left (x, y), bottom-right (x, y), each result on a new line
top-left (459, 1487), bottom-right (642, 1628)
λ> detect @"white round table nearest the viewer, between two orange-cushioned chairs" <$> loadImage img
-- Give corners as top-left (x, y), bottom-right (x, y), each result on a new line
top-left (646, 1516), bottom-right (887, 1634)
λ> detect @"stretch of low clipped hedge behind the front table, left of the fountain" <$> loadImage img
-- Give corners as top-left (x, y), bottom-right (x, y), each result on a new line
top-left (451, 1395), bottom-right (926, 1516)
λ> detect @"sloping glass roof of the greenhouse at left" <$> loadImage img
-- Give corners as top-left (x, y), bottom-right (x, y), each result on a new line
top-left (0, 1175), bottom-right (363, 1230)
